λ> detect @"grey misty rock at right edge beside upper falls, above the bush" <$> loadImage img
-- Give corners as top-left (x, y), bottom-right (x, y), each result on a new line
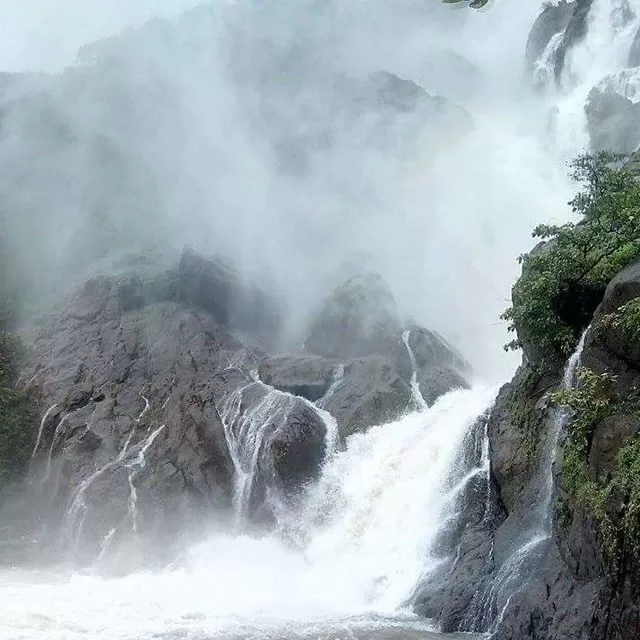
top-left (585, 84), bottom-right (640, 154)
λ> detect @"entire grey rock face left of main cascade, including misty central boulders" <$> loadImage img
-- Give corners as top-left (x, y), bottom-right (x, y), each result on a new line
top-left (0, 250), bottom-right (467, 563)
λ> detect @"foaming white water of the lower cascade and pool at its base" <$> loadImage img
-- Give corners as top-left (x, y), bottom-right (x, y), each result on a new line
top-left (0, 388), bottom-right (495, 640)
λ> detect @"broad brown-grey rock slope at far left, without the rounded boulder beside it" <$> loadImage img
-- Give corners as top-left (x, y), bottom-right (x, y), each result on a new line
top-left (17, 258), bottom-right (276, 560)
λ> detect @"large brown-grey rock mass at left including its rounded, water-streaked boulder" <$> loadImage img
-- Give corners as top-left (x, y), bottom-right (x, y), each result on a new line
top-left (7, 251), bottom-right (316, 560)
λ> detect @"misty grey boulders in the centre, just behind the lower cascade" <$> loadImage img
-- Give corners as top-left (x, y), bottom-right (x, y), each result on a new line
top-left (288, 274), bottom-right (469, 437)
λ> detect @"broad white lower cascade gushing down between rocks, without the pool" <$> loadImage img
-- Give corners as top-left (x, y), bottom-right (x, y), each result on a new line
top-left (292, 388), bottom-right (495, 610)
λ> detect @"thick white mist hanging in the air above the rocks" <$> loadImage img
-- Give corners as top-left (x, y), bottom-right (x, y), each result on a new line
top-left (0, 0), bottom-right (572, 378)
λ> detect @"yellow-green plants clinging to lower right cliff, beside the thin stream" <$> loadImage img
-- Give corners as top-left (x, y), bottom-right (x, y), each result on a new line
top-left (553, 368), bottom-right (640, 567)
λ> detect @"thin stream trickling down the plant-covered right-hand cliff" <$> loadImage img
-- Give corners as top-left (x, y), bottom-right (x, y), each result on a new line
top-left (472, 327), bottom-right (590, 632)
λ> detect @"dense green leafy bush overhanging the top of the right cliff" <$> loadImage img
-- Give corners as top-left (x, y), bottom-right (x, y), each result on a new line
top-left (502, 153), bottom-right (640, 357)
